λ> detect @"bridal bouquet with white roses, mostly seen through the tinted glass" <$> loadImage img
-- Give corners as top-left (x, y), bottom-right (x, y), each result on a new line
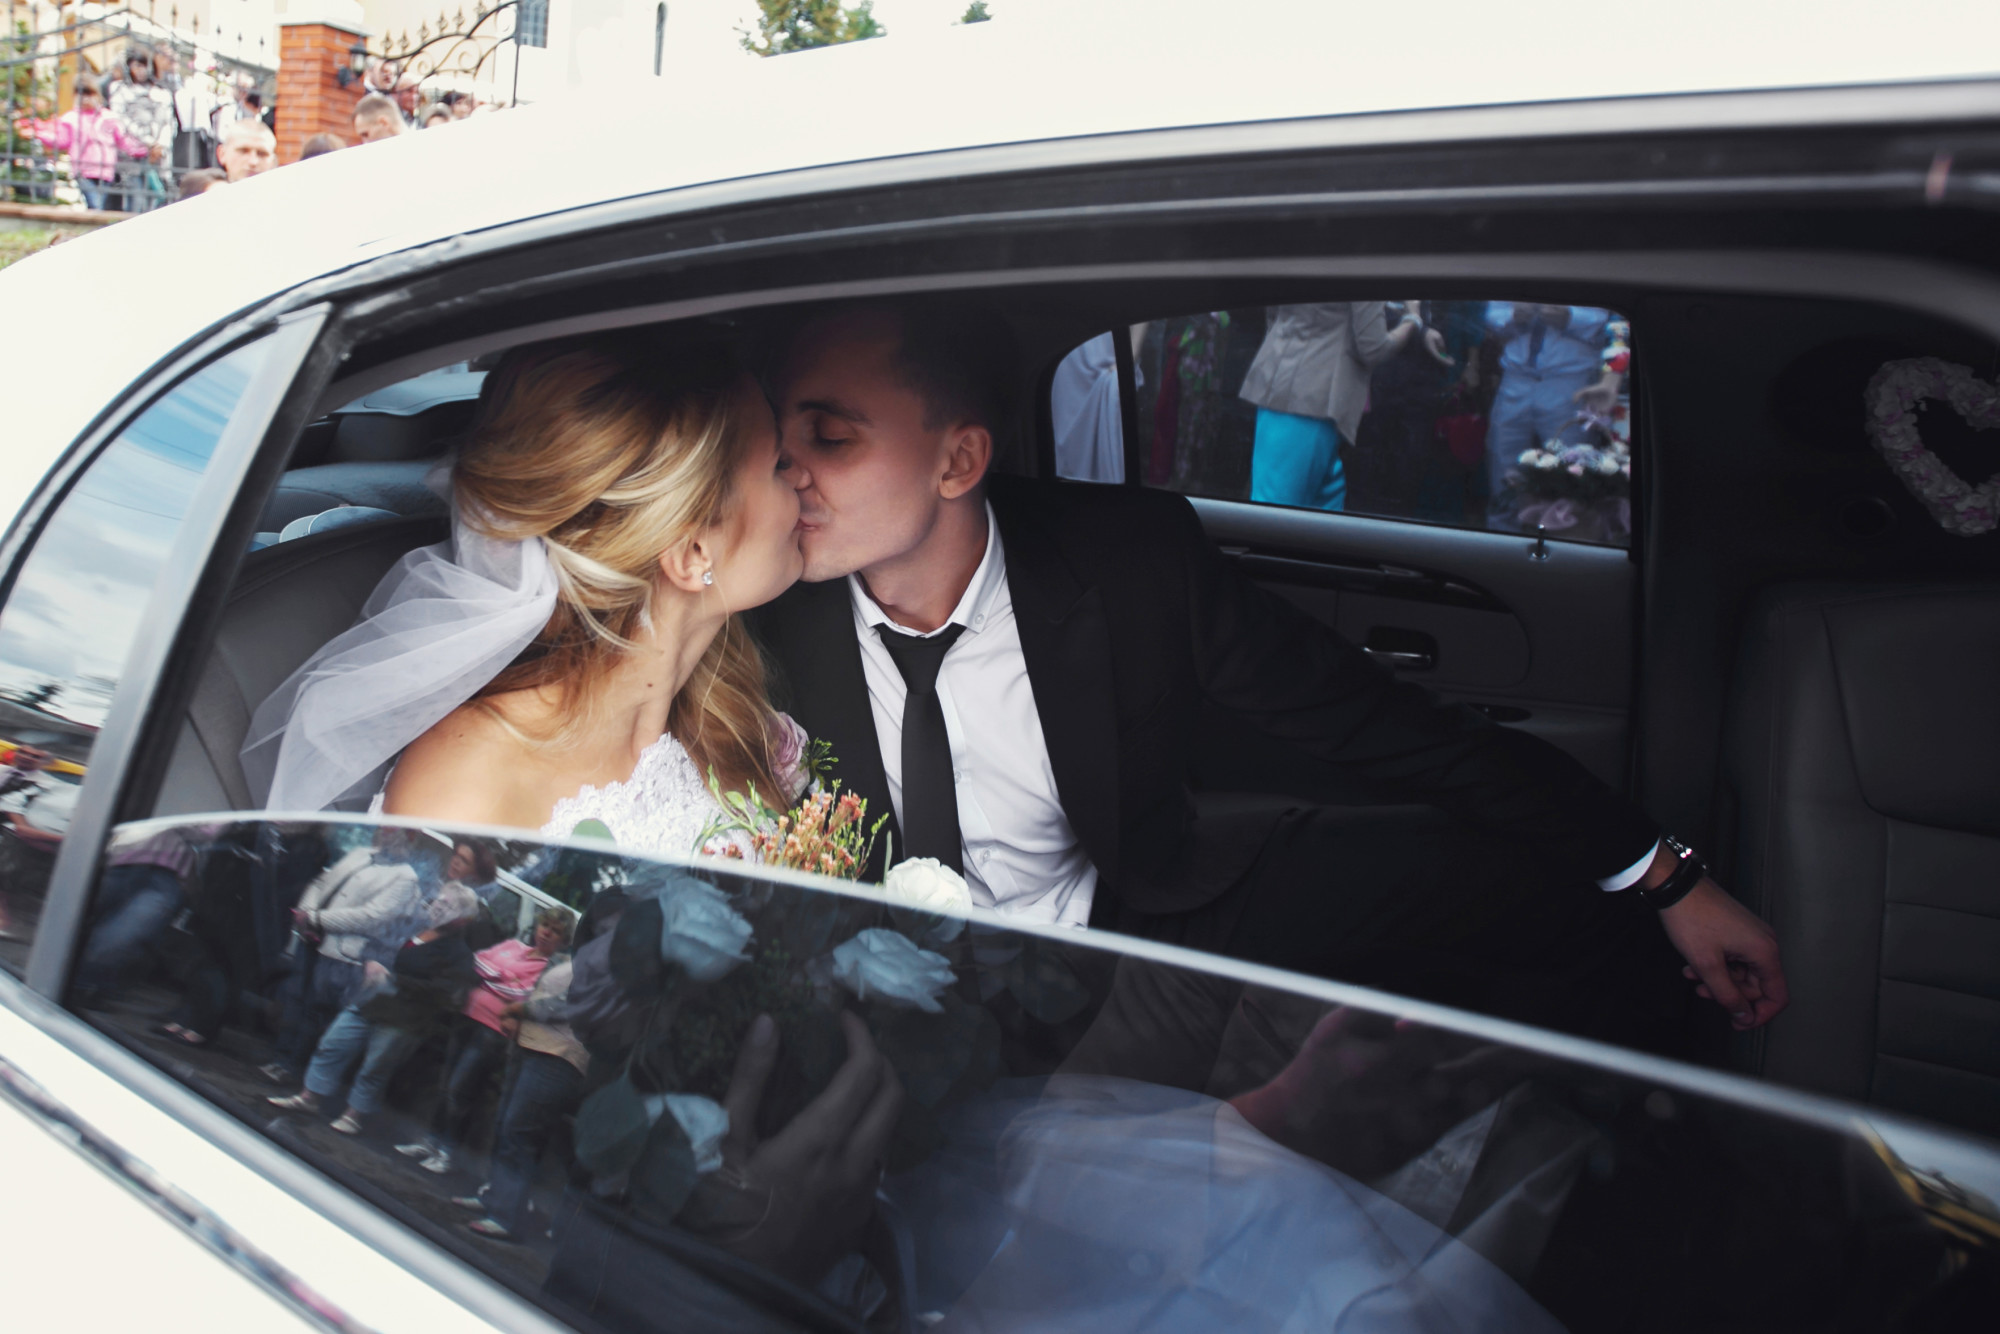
top-left (572, 852), bottom-right (1090, 1232)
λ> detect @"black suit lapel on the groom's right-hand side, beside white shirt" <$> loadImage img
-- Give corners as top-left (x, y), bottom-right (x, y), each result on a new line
top-left (992, 478), bottom-right (1118, 882)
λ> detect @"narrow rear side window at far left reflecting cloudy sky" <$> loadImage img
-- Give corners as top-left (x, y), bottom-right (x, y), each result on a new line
top-left (0, 342), bottom-right (270, 970)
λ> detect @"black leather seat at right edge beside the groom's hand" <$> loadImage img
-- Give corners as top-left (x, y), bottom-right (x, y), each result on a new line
top-left (1726, 584), bottom-right (2000, 1136)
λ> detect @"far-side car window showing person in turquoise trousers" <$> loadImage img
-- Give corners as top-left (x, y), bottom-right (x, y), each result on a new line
top-left (1050, 300), bottom-right (1632, 546)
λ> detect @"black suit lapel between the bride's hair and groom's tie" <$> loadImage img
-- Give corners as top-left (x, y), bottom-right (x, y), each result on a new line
top-left (756, 580), bottom-right (902, 880)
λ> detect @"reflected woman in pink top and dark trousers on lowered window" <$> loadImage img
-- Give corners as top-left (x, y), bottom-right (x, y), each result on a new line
top-left (396, 908), bottom-right (570, 1172)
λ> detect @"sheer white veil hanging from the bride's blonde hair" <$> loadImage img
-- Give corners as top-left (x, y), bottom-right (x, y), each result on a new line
top-left (242, 508), bottom-right (556, 810)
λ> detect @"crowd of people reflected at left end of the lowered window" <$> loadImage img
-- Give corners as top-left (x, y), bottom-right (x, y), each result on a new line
top-left (76, 824), bottom-right (588, 1240)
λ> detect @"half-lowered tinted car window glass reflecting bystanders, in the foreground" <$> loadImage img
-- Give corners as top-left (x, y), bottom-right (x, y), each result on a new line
top-left (72, 818), bottom-right (2000, 1332)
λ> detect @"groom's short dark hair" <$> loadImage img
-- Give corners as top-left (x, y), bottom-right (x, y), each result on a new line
top-left (796, 296), bottom-right (1020, 442)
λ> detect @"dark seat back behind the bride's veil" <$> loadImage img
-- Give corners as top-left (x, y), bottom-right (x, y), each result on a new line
top-left (154, 518), bottom-right (450, 816)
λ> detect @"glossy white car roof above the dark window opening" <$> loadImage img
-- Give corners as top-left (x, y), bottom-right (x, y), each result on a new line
top-left (11, 0), bottom-right (2000, 528)
